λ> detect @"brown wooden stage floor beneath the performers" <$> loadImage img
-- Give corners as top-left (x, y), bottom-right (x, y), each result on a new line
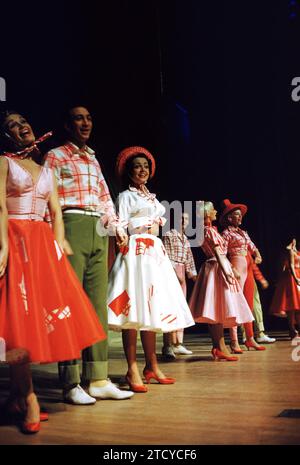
top-left (0, 333), bottom-right (300, 446)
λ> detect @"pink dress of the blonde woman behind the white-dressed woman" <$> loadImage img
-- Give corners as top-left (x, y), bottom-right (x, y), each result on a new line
top-left (189, 226), bottom-right (253, 328)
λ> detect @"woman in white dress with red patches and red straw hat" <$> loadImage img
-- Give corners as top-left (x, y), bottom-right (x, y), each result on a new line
top-left (108, 147), bottom-right (194, 392)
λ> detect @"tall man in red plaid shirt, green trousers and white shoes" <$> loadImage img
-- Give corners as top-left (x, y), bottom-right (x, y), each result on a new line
top-left (45, 106), bottom-right (133, 404)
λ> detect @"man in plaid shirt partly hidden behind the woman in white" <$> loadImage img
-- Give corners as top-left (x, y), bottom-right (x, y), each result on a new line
top-left (162, 213), bottom-right (197, 360)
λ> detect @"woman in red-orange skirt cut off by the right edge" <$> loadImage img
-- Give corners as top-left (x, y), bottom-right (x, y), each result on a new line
top-left (270, 239), bottom-right (300, 339)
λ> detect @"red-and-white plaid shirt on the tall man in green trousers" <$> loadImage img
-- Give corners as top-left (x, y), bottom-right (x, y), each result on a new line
top-left (45, 142), bottom-right (118, 226)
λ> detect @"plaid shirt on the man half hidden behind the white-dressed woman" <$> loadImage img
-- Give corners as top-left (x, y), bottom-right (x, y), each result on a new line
top-left (163, 229), bottom-right (197, 276)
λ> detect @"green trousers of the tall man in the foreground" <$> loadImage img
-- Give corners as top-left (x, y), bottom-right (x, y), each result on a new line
top-left (58, 213), bottom-right (108, 388)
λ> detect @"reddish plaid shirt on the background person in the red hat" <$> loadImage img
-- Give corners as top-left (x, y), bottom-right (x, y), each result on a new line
top-left (222, 226), bottom-right (256, 256)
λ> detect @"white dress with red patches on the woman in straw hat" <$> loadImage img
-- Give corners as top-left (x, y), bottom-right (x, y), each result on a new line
top-left (108, 188), bottom-right (195, 332)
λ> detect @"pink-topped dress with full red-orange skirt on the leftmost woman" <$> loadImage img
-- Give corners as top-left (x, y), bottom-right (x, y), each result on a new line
top-left (0, 157), bottom-right (106, 362)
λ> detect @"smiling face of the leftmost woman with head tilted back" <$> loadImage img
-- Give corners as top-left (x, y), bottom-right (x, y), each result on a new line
top-left (4, 113), bottom-right (35, 147)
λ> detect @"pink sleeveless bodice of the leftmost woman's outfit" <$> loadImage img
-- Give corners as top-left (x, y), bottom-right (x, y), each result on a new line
top-left (5, 157), bottom-right (53, 221)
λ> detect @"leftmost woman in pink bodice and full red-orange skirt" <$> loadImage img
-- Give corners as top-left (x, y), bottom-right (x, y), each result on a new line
top-left (0, 112), bottom-right (106, 433)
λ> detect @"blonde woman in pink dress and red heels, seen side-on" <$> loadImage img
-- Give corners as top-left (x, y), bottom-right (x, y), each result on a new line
top-left (189, 202), bottom-right (253, 361)
